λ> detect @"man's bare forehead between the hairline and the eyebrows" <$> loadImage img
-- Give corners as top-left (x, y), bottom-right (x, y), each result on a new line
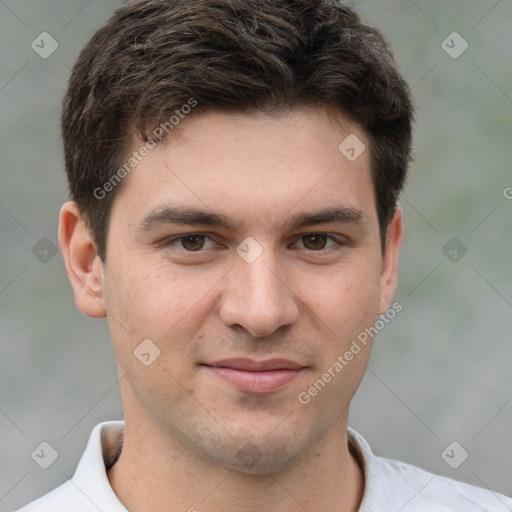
top-left (112, 108), bottom-right (375, 232)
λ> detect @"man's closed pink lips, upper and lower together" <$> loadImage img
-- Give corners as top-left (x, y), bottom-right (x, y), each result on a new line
top-left (202, 358), bottom-right (305, 394)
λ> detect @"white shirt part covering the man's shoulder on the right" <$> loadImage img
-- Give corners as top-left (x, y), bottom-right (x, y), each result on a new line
top-left (349, 429), bottom-right (512, 512)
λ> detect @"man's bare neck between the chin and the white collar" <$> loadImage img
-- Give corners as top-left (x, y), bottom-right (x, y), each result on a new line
top-left (108, 411), bottom-right (364, 512)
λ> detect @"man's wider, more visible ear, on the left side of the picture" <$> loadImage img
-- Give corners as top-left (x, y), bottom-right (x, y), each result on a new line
top-left (59, 201), bottom-right (107, 318)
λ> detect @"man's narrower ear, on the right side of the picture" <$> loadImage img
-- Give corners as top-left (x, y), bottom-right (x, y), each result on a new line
top-left (379, 206), bottom-right (404, 315)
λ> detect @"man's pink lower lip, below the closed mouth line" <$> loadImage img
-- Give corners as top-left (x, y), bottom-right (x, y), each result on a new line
top-left (204, 366), bottom-right (303, 393)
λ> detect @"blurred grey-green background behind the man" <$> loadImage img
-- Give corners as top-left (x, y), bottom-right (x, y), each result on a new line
top-left (0, 0), bottom-right (512, 511)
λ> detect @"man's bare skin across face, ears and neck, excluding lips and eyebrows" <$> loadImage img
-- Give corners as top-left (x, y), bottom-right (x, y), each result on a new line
top-left (59, 108), bottom-right (403, 512)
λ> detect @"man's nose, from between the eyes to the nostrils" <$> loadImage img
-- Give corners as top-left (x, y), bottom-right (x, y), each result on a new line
top-left (219, 249), bottom-right (299, 337)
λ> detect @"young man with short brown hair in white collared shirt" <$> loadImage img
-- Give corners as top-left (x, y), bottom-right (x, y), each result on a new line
top-left (16, 0), bottom-right (512, 512)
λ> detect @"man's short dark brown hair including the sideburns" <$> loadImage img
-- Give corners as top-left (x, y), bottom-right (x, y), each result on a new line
top-left (61, 0), bottom-right (413, 260)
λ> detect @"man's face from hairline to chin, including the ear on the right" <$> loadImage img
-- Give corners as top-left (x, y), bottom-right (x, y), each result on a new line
top-left (64, 109), bottom-right (401, 473)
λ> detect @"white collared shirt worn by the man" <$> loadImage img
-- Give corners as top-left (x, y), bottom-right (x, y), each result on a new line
top-left (18, 421), bottom-right (512, 512)
